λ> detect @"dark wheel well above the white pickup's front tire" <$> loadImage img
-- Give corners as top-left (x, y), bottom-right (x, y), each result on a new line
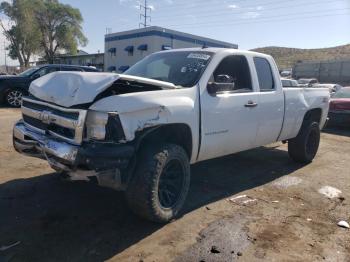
top-left (136, 124), bottom-right (192, 159)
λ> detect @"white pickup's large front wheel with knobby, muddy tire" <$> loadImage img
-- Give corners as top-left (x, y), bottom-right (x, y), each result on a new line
top-left (126, 144), bottom-right (190, 223)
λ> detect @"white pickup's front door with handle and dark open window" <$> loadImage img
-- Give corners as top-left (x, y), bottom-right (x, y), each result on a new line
top-left (198, 55), bottom-right (259, 160)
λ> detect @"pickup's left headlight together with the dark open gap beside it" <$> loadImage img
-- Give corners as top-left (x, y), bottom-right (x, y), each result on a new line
top-left (86, 111), bottom-right (125, 142)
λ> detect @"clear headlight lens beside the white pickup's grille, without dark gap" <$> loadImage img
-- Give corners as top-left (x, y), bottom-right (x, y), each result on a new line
top-left (86, 111), bottom-right (108, 140)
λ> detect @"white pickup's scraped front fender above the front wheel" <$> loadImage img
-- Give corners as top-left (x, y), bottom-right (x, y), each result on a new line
top-left (90, 90), bottom-right (198, 141)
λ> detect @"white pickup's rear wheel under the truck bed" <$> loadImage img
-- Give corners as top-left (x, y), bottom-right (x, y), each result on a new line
top-left (288, 122), bottom-right (320, 163)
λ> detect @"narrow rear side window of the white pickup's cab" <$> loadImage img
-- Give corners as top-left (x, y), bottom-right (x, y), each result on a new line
top-left (254, 57), bottom-right (275, 92)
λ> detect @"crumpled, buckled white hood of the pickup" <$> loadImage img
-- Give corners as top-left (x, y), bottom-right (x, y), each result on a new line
top-left (29, 72), bottom-right (176, 107)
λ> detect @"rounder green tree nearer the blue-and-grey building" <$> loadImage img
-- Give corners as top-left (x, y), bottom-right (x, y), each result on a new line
top-left (34, 0), bottom-right (87, 63)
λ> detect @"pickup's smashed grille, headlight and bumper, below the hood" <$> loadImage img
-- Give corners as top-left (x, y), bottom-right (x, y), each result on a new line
top-left (13, 98), bottom-right (134, 189)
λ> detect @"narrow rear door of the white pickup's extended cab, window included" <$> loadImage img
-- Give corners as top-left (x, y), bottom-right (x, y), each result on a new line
top-left (253, 57), bottom-right (284, 146)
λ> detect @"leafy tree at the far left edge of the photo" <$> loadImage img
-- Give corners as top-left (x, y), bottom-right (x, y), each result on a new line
top-left (0, 0), bottom-right (40, 68)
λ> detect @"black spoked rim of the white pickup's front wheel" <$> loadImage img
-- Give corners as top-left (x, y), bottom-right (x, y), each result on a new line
top-left (158, 160), bottom-right (184, 208)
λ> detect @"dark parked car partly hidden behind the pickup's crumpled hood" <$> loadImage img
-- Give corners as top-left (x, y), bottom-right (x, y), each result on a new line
top-left (0, 65), bottom-right (98, 107)
